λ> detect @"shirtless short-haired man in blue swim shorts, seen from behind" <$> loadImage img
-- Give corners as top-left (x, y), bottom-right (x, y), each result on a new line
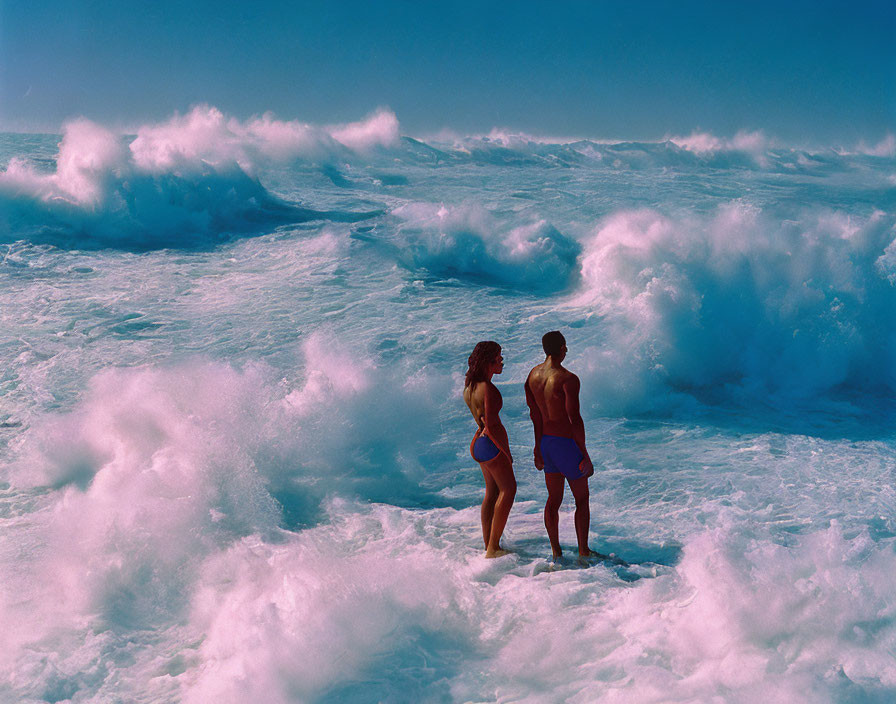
top-left (526, 330), bottom-right (606, 558)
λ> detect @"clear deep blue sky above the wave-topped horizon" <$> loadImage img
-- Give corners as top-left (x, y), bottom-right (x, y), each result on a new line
top-left (0, 0), bottom-right (896, 143)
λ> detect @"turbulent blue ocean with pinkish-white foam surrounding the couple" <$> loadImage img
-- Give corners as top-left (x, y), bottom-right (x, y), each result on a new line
top-left (0, 106), bottom-right (896, 703)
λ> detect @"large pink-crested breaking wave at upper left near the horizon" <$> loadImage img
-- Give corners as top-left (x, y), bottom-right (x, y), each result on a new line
top-left (0, 107), bottom-right (398, 250)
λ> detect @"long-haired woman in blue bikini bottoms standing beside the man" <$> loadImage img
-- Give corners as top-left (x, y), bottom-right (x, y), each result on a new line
top-left (464, 342), bottom-right (516, 557)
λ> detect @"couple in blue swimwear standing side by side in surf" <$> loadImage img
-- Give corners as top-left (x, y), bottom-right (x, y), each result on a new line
top-left (464, 330), bottom-right (606, 558)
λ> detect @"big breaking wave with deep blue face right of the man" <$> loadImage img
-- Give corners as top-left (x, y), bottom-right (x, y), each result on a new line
top-left (571, 202), bottom-right (896, 408)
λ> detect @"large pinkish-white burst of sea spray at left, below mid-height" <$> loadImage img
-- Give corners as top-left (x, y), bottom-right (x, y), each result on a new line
top-left (2, 364), bottom-right (279, 637)
